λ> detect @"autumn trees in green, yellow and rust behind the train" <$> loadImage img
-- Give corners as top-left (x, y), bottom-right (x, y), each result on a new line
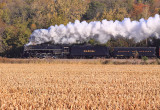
top-left (0, 0), bottom-right (160, 57)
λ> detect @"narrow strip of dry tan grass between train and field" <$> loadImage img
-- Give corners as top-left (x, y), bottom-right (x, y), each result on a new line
top-left (0, 57), bottom-right (160, 65)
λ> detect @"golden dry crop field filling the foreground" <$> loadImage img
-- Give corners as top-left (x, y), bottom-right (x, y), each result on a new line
top-left (0, 64), bottom-right (160, 110)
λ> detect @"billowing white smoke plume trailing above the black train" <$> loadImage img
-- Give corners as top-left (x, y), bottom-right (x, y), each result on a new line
top-left (27, 14), bottom-right (160, 45)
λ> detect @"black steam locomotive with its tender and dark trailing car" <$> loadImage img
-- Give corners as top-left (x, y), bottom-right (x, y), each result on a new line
top-left (23, 44), bottom-right (160, 58)
